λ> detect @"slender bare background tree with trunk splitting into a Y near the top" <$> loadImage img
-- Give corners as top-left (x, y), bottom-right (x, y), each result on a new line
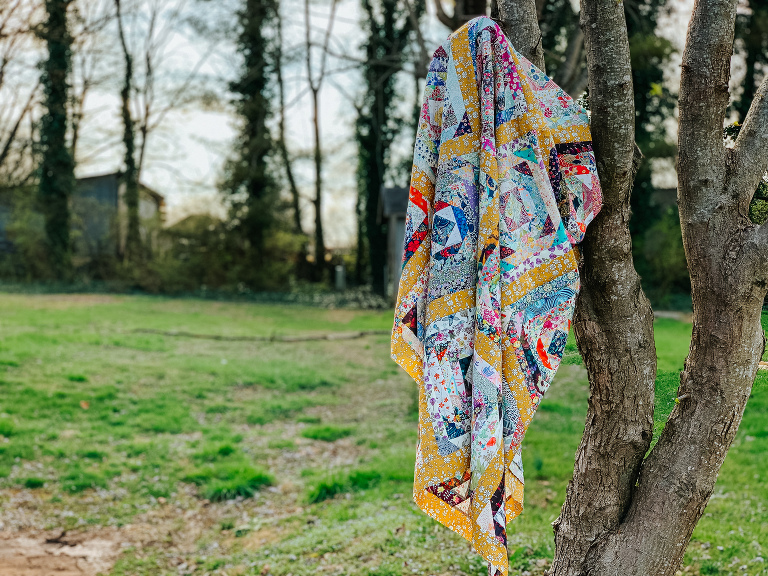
top-left (304, 0), bottom-right (338, 279)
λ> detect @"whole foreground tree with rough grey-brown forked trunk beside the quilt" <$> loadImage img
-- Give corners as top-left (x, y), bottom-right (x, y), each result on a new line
top-left (499, 0), bottom-right (768, 576)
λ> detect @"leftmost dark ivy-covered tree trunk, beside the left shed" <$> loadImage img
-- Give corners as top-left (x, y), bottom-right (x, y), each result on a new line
top-left (38, 0), bottom-right (75, 280)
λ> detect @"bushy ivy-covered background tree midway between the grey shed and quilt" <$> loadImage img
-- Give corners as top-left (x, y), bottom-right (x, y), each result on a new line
top-left (224, 0), bottom-right (278, 282)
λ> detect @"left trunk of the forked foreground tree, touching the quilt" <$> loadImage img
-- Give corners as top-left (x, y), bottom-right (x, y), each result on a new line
top-left (552, 0), bottom-right (656, 576)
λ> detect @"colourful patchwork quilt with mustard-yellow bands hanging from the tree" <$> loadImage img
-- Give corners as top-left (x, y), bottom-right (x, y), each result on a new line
top-left (392, 17), bottom-right (602, 576)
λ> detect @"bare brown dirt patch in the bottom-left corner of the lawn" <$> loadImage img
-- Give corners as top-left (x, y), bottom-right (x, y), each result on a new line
top-left (0, 530), bottom-right (120, 576)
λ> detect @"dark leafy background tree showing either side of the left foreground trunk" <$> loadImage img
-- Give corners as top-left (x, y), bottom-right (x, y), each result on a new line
top-left (536, 0), bottom-right (690, 300)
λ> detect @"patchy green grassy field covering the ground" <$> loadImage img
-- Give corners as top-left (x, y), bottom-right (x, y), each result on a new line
top-left (0, 295), bottom-right (768, 576)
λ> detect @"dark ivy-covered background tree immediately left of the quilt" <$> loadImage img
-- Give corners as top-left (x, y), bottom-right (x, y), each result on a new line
top-left (355, 0), bottom-right (424, 294)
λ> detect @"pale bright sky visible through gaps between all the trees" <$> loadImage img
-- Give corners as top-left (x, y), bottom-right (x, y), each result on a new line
top-left (6, 0), bottom-right (752, 247)
